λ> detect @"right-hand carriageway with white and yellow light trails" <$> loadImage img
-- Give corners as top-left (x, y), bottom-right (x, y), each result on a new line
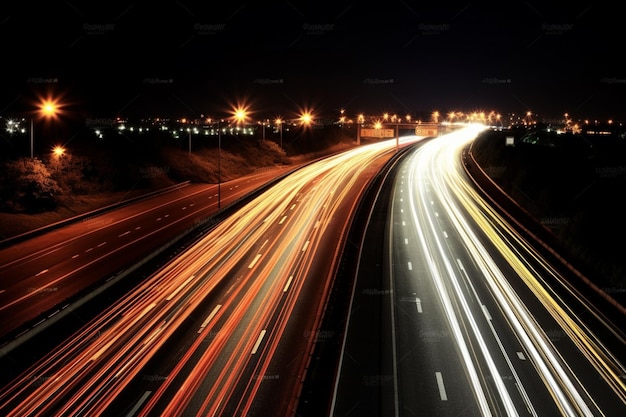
top-left (330, 127), bottom-right (626, 417)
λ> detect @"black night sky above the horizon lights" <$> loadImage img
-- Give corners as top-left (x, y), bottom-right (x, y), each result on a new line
top-left (0, 0), bottom-right (626, 120)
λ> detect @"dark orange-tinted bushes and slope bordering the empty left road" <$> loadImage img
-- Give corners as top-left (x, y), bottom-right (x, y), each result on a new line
top-left (0, 122), bottom-right (354, 240)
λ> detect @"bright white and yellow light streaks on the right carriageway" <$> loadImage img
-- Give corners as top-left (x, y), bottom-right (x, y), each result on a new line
top-left (400, 124), bottom-right (626, 416)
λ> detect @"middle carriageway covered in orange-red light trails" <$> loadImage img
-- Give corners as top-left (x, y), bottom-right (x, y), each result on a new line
top-left (0, 137), bottom-right (416, 416)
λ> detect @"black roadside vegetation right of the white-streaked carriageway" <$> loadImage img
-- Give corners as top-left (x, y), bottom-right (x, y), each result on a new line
top-left (474, 127), bottom-right (626, 300)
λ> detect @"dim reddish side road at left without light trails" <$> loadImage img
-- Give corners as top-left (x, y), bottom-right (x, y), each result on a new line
top-left (0, 168), bottom-right (286, 344)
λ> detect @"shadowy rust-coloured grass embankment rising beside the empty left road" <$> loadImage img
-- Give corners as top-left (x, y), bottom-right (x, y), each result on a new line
top-left (0, 132), bottom-right (351, 240)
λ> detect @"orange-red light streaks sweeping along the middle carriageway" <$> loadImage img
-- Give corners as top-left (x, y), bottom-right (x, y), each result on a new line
top-left (0, 135), bottom-right (414, 416)
